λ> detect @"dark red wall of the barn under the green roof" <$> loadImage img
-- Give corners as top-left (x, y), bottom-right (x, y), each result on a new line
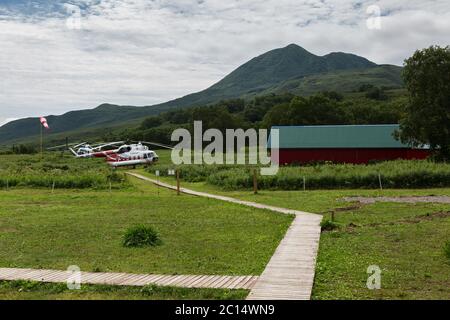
top-left (272, 148), bottom-right (430, 165)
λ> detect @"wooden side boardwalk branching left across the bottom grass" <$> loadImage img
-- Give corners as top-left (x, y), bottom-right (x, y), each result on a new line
top-left (0, 268), bottom-right (258, 290)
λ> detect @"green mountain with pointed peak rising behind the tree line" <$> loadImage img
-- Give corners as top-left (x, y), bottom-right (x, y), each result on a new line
top-left (0, 44), bottom-right (403, 144)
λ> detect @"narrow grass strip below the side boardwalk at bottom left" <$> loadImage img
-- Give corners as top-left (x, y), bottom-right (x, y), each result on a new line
top-left (0, 281), bottom-right (248, 300)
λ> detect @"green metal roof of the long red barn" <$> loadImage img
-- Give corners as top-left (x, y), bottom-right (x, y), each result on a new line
top-left (269, 124), bottom-right (409, 149)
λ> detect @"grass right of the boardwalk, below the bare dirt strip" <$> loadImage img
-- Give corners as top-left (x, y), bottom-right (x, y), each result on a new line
top-left (313, 203), bottom-right (450, 299)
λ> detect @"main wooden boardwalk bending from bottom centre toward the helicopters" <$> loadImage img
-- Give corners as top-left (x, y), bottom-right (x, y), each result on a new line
top-left (127, 172), bottom-right (322, 300)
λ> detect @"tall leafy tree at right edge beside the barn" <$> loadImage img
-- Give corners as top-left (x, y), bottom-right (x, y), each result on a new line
top-left (398, 46), bottom-right (450, 159)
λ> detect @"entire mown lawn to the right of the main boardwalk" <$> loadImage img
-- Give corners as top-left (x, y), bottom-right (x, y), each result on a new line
top-left (137, 172), bottom-right (450, 299)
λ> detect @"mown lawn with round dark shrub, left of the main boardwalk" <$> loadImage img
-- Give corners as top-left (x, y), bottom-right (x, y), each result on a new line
top-left (0, 175), bottom-right (293, 275)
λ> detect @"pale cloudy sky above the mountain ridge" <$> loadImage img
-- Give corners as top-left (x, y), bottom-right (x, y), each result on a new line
top-left (0, 0), bottom-right (450, 119)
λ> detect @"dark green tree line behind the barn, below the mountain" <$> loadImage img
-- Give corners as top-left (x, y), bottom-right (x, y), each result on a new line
top-left (108, 92), bottom-right (404, 143)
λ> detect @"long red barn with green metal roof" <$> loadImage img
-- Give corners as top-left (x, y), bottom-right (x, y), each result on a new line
top-left (269, 124), bottom-right (430, 165)
